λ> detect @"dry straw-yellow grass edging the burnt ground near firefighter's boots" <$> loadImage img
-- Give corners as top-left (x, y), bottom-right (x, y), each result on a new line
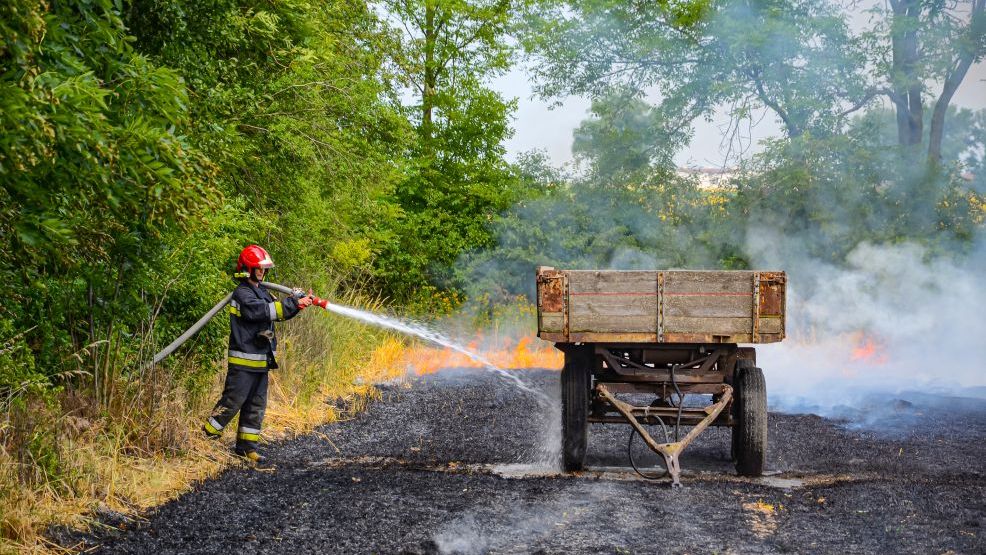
top-left (0, 370), bottom-right (408, 553)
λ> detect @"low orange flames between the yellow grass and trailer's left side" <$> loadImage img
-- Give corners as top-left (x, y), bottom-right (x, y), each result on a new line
top-left (399, 336), bottom-right (564, 375)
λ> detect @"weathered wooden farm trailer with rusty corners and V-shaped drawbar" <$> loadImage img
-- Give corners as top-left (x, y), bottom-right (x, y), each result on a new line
top-left (537, 267), bottom-right (786, 485)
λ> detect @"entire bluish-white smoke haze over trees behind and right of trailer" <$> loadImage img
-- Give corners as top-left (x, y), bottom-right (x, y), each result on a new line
top-left (456, 2), bottom-right (986, 432)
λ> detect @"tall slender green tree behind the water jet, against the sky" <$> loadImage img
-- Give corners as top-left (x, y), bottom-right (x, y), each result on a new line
top-left (377, 0), bottom-right (514, 300)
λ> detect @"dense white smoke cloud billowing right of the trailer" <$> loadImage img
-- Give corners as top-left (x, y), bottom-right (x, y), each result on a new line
top-left (747, 229), bottom-right (986, 421)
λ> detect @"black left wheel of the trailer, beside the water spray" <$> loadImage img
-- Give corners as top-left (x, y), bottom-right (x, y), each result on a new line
top-left (561, 346), bottom-right (593, 472)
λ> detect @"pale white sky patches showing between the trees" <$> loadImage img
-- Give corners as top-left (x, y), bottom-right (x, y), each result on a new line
top-left (493, 12), bottom-right (986, 167)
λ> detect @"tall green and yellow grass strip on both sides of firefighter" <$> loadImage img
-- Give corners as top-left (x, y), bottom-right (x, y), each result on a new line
top-left (0, 286), bottom-right (406, 552)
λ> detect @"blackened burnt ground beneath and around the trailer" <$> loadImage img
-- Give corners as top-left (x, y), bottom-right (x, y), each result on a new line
top-left (65, 370), bottom-right (986, 553)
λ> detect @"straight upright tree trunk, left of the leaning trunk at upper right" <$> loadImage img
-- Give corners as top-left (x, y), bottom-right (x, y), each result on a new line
top-left (890, 0), bottom-right (924, 146)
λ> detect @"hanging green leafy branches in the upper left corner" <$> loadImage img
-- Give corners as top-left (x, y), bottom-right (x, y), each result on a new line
top-left (0, 2), bottom-right (208, 271)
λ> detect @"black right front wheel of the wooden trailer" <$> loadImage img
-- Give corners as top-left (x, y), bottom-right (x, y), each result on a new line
top-left (732, 360), bottom-right (767, 476)
